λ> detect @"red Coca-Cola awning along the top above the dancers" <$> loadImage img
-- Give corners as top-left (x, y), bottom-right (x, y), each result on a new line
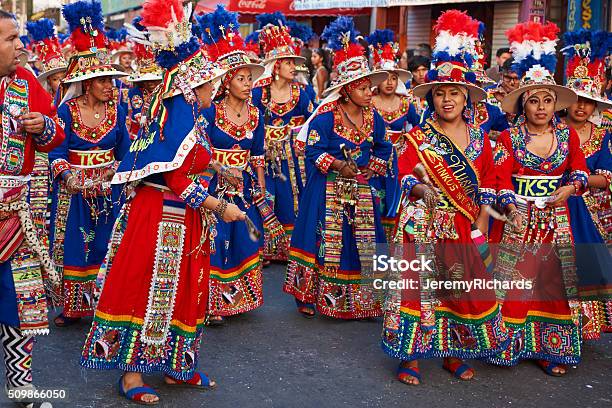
top-left (195, 0), bottom-right (368, 17)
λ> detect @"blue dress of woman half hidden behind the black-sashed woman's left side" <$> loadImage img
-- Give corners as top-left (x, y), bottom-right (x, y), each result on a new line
top-left (373, 96), bottom-right (420, 241)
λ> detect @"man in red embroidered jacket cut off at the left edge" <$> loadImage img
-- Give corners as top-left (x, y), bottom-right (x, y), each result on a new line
top-left (0, 10), bottom-right (64, 398)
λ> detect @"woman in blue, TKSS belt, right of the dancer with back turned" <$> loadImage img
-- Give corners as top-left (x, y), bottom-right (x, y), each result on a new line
top-left (198, 5), bottom-right (266, 324)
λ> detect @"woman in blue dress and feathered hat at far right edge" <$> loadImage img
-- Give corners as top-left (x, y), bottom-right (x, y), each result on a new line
top-left (564, 29), bottom-right (612, 339)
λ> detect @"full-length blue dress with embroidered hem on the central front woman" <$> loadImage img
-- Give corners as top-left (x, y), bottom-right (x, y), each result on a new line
top-left (283, 101), bottom-right (392, 319)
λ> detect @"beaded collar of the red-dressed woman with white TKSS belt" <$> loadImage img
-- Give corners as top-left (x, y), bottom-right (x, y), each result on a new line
top-left (509, 123), bottom-right (570, 173)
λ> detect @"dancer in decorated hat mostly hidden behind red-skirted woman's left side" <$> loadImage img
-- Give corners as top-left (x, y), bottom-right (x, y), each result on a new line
top-left (126, 16), bottom-right (163, 140)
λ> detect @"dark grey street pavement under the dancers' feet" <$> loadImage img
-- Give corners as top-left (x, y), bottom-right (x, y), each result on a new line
top-left (0, 265), bottom-right (612, 408)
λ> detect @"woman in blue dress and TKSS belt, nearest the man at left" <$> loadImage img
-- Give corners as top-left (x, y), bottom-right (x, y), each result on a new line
top-left (49, 1), bottom-right (130, 326)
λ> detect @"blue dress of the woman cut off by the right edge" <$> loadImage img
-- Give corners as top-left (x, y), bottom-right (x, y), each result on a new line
top-left (568, 125), bottom-right (612, 339)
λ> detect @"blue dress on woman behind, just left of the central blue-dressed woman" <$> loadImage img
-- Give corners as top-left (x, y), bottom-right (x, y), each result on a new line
top-left (253, 82), bottom-right (314, 261)
